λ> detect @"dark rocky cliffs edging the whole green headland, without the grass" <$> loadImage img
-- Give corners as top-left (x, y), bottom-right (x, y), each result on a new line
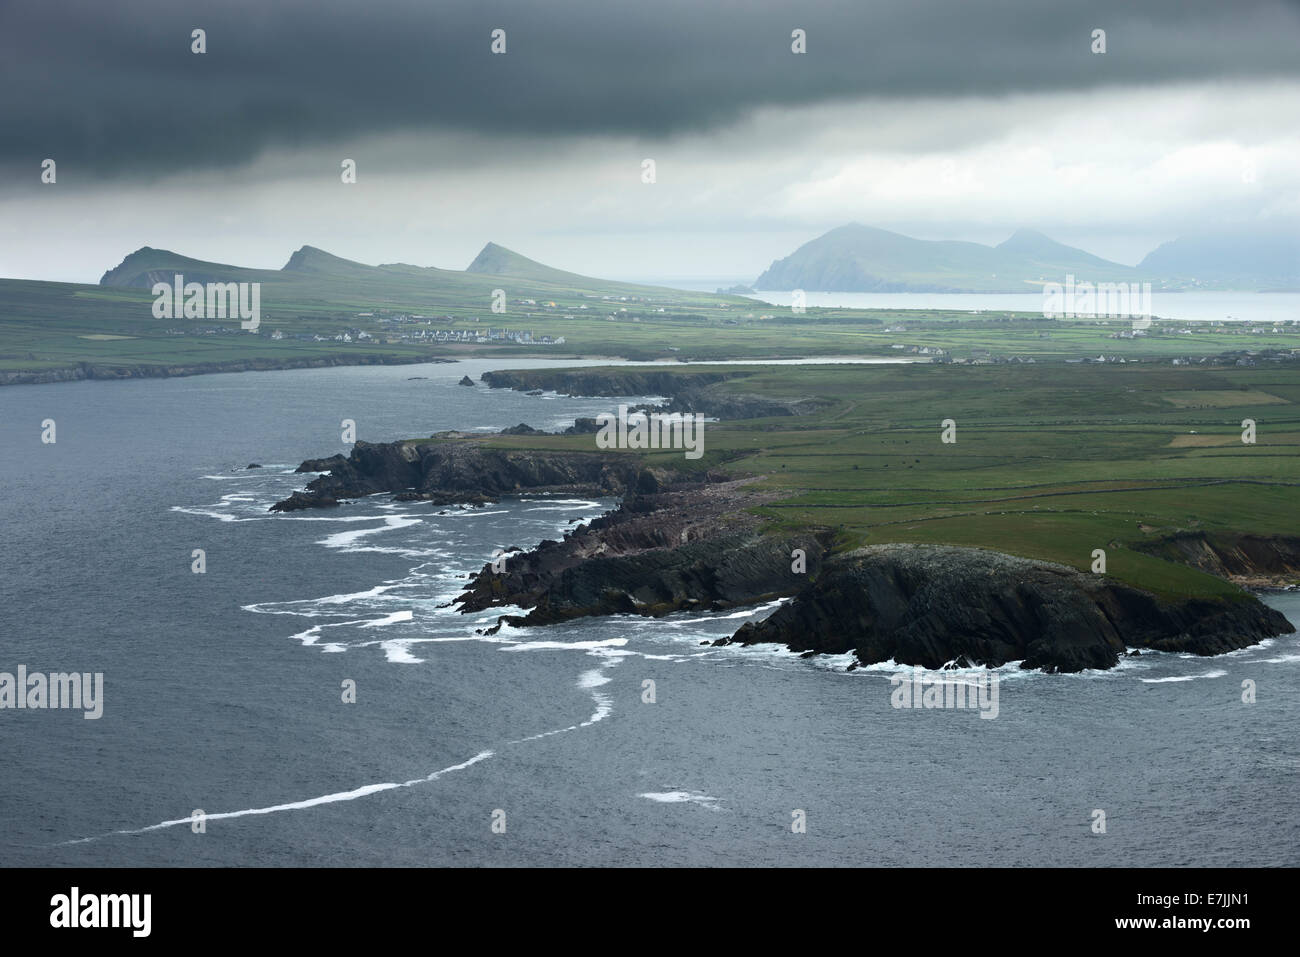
top-left (272, 369), bottom-right (1300, 672)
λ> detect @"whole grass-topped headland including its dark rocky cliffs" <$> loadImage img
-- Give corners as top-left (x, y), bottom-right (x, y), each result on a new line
top-left (274, 363), bottom-right (1300, 671)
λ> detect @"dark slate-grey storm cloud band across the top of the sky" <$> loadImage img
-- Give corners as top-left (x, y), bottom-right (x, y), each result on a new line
top-left (0, 0), bottom-right (1300, 182)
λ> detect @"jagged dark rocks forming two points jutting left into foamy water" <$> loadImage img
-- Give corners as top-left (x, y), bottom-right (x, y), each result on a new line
top-left (272, 439), bottom-right (831, 624)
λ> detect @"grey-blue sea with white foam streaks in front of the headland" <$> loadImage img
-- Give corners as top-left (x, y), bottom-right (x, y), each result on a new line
top-left (0, 360), bottom-right (1300, 866)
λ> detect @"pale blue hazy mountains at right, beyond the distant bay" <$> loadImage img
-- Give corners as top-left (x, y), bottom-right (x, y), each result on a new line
top-left (754, 222), bottom-right (1300, 293)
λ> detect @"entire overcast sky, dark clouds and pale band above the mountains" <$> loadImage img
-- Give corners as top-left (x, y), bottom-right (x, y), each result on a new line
top-left (0, 0), bottom-right (1300, 282)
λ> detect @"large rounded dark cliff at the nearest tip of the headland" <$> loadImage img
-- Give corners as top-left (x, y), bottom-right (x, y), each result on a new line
top-left (719, 545), bottom-right (1294, 672)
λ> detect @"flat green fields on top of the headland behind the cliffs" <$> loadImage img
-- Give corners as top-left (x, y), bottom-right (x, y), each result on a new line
top-left (467, 364), bottom-right (1300, 596)
